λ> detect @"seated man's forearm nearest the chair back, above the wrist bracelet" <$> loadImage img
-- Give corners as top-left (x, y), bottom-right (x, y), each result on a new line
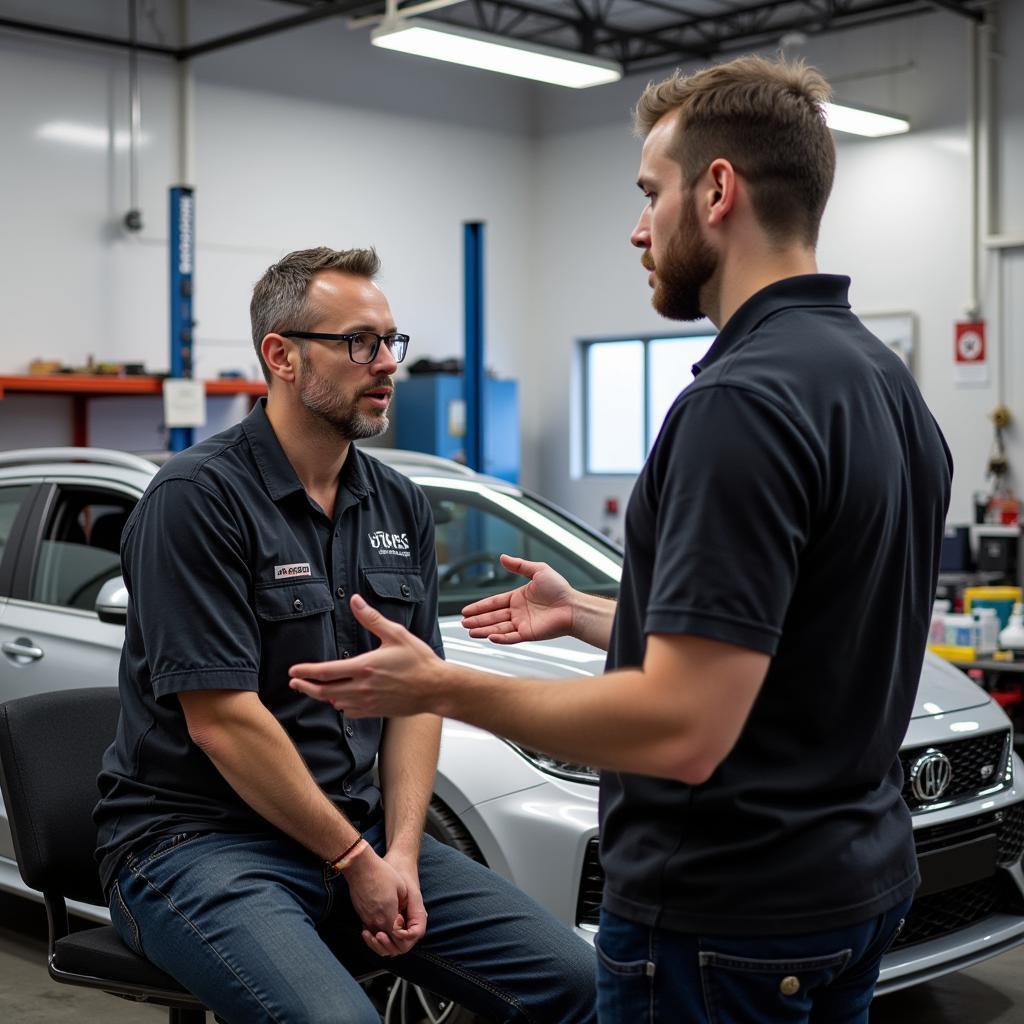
top-left (182, 692), bottom-right (358, 860)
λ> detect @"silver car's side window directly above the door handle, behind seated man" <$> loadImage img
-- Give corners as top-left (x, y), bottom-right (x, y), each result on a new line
top-left (32, 488), bottom-right (134, 611)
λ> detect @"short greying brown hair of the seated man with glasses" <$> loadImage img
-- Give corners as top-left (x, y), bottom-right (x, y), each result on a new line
top-left (249, 246), bottom-right (381, 384)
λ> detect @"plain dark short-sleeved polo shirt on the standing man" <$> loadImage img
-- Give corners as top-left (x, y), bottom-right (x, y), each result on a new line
top-left (601, 274), bottom-right (952, 935)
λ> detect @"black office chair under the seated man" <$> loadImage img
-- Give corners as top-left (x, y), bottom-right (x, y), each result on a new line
top-left (0, 687), bottom-right (206, 1024)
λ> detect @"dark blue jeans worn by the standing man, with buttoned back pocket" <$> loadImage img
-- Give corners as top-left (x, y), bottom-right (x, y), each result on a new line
top-left (596, 900), bottom-right (910, 1024)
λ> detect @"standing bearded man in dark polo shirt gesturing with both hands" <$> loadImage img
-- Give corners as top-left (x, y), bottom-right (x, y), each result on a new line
top-left (292, 56), bottom-right (951, 1024)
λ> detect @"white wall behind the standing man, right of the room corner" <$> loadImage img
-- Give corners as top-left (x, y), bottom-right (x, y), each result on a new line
top-left (531, 4), bottom-right (1024, 522)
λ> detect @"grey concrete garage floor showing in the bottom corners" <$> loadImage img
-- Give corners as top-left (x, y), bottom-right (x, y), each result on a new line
top-left (0, 895), bottom-right (1024, 1024)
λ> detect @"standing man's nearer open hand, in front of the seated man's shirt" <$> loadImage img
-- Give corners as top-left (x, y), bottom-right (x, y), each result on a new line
top-left (289, 594), bottom-right (444, 718)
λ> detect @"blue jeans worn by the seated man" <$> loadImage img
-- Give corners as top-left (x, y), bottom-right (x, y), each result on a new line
top-left (110, 824), bottom-right (596, 1024)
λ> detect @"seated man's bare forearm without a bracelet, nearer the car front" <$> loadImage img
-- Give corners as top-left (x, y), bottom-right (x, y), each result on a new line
top-left (379, 715), bottom-right (441, 860)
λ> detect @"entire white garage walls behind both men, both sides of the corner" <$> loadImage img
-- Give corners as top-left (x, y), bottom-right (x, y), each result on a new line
top-left (0, 0), bottom-right (1024, 521)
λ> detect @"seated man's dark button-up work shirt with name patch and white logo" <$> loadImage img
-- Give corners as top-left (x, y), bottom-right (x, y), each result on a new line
top-left (95, 401), bottom-right (443, 887)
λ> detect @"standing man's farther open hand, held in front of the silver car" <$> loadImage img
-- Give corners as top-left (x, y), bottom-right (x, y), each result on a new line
top-left (462, 555), bottom-right (575, 644)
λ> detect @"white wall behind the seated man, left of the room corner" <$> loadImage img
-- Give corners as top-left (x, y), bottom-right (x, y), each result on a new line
top-left (0, 0), bottom-right (535, 464)
